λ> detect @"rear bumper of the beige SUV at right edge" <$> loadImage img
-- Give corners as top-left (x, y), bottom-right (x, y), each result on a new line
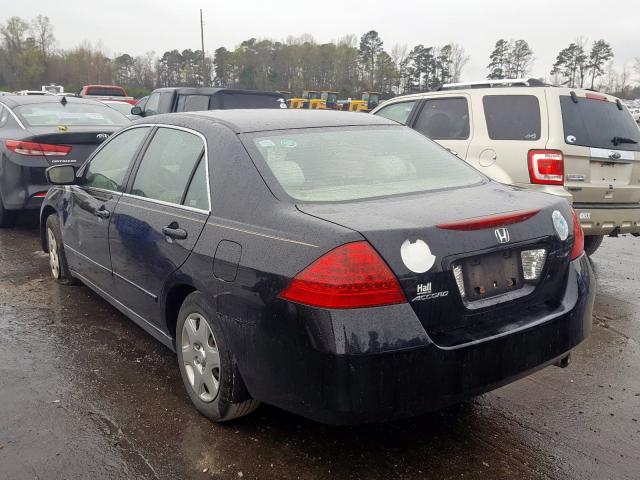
top-left (573, 203), bottom-right (640, 235)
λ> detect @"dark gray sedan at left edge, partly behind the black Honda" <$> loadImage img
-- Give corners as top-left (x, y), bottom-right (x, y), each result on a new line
top-left (0, 95), bottom-right (129, 227)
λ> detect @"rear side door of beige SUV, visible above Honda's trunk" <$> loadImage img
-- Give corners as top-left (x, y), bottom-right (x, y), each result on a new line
top-left (411, 94), bottom-right (471, 159)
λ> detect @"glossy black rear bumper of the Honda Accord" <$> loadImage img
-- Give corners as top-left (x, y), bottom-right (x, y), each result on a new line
top-left (239, 255), bottom-right (595, 424)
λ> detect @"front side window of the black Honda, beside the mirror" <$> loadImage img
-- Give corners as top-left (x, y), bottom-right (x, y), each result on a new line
top-left (82, 127), bottom-right (149, 192)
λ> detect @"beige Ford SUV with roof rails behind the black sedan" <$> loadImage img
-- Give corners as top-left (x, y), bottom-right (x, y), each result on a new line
top-left (371, 80), bottom-right (640, 254)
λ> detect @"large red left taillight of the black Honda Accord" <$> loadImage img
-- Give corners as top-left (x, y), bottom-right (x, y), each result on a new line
top-left (280, 242), bottom-right (407, 308)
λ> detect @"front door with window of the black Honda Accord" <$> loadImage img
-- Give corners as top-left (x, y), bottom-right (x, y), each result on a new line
top-left (62, 127), bottom-right (149, 288)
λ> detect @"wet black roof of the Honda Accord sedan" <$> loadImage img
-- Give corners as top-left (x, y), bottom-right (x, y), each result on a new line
top-left (152, 108), bottom-right (398, 133)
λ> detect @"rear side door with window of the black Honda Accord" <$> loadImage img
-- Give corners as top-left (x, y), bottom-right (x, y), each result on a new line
top-left (109, 126), bottom-right (210, 322)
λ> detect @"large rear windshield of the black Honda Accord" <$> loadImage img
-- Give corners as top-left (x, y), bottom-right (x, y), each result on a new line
top-left (249, 126), bottom-right (484, 202)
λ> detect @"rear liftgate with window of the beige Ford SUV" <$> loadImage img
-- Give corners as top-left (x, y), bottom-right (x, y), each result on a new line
top-left (549, 92), bottom-right (640, 204)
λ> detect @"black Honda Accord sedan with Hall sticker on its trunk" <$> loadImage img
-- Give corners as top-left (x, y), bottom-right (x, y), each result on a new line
top-left (41, 110), bottom-right (595, 424)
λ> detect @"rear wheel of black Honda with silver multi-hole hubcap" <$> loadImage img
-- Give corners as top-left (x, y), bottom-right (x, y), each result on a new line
top-left (176, 292), bottom-right (260, 422)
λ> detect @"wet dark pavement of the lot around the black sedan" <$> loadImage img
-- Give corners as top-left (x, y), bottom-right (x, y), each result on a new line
top-left (0, 216), bottom-right (640, 480)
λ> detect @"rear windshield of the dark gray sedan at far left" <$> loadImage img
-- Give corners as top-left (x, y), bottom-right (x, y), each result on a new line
top-left (14, 102), bottom-right (131, 127)
